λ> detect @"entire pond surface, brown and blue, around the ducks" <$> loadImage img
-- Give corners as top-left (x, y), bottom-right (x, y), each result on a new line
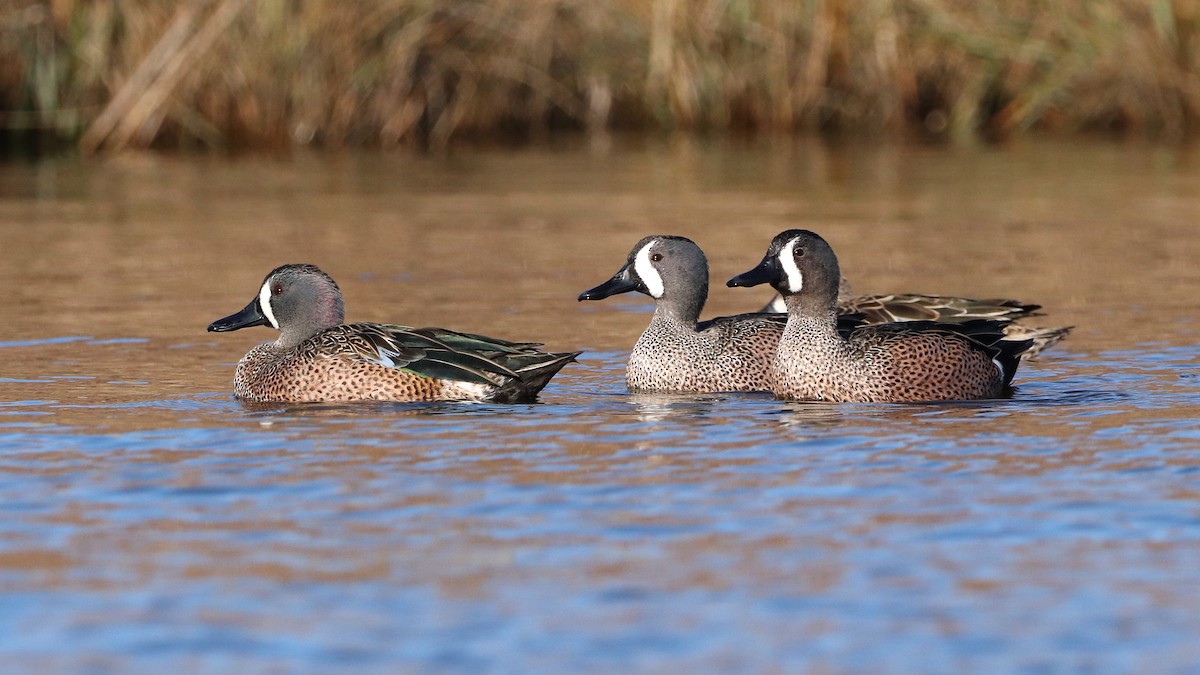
top-left (0, 141), bottom-right (1200, 673)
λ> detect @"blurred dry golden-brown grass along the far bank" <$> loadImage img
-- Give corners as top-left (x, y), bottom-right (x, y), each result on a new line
top-left (0, 0), bottom-right (1200, 151)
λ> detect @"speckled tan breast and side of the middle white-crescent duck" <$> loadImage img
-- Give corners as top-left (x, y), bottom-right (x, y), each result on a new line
top-left (625, 317), bottom-right (784, 392)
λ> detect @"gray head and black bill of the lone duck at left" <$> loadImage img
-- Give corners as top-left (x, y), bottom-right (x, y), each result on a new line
top-left (209, 264), bottom-right (346, 348)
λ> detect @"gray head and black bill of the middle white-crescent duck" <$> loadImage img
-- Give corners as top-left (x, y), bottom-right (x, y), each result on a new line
top-left (580, 234), bottom-right (708, 323)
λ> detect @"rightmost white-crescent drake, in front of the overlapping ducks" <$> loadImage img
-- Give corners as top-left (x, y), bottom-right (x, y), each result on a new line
top-left (728, 229), bottom-right (1032, 402)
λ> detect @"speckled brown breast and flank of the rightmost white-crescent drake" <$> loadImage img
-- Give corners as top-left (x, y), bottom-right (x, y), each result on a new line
top-left (772, 319), bottom-right (1004, 402)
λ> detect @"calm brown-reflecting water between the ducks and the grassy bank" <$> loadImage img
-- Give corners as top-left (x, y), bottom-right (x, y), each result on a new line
top-left (0, 135), bottom-right (1200, 351)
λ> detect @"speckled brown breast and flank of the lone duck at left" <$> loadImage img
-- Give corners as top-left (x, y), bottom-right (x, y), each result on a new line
top-left (234, 344), bottom-right (488, 402)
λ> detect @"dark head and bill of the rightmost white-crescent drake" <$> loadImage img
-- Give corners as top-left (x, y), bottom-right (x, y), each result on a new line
top-left (728, 229), bottom-right (841, 311)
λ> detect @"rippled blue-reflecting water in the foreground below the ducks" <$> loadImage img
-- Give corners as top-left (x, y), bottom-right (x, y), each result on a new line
top-left (0, 347), bottom-right (1200, 673)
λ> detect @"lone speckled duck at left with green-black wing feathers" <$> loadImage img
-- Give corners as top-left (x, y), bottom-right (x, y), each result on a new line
top-left (209, 264), bottom-right (580, 402)
